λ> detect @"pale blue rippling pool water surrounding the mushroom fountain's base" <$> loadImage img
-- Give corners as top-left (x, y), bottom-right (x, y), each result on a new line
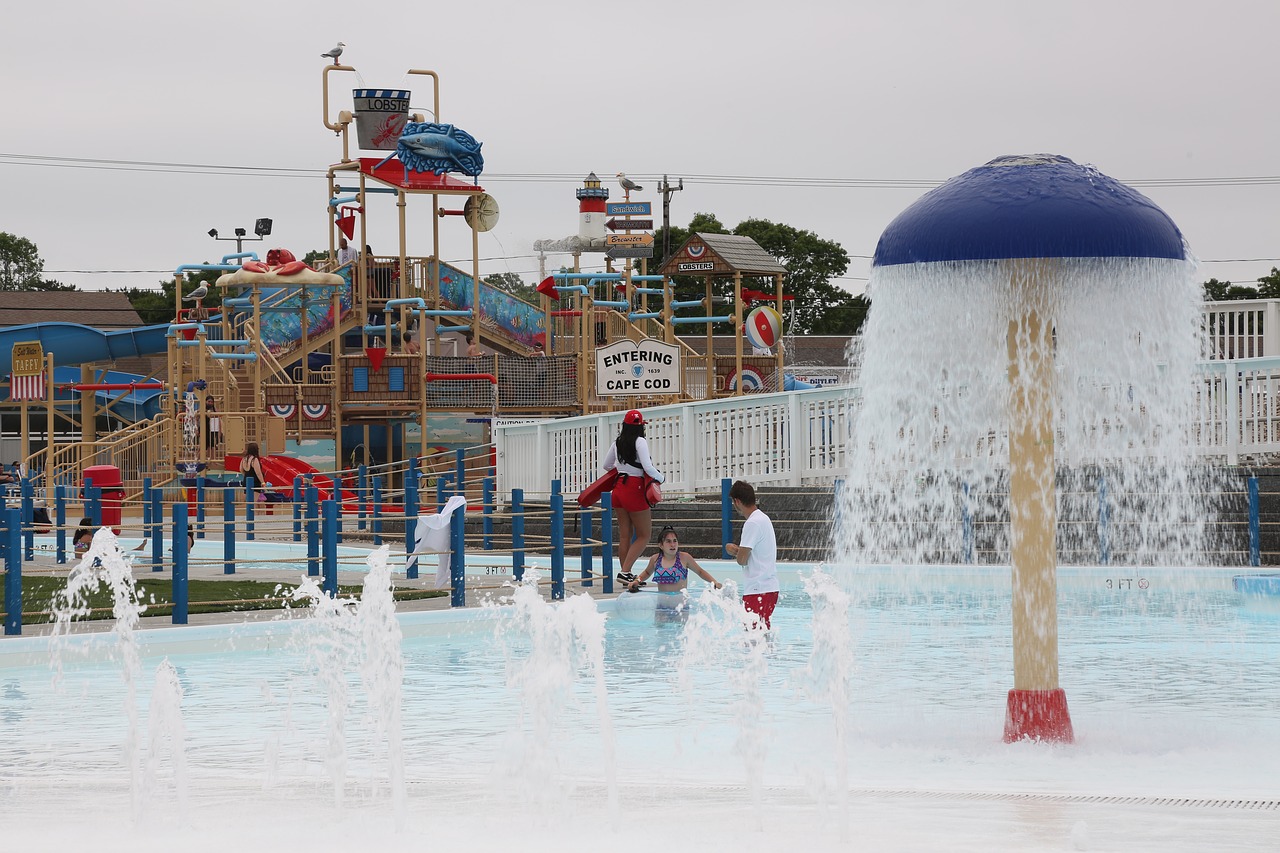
top-left (0, 560), bottom-right (1280, 849)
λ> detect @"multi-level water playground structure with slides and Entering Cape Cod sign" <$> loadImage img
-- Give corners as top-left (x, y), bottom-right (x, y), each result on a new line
top-left (0, 64), bottom-right (787, 512)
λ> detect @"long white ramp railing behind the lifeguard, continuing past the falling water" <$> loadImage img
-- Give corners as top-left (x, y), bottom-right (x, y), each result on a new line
top-left (493, 357), bottom-right (1280, 496)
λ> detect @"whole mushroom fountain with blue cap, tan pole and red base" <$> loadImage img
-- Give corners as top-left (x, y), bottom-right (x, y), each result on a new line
top-left (873, 155), bottom-right (1185, 743)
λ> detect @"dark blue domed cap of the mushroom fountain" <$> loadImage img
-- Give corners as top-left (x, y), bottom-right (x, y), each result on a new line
top-left (872, 154), bottom-right (1187, 266)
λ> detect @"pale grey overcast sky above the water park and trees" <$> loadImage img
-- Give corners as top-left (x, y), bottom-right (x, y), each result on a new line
top-left (0, 0), bottom-right (1280, 298)
